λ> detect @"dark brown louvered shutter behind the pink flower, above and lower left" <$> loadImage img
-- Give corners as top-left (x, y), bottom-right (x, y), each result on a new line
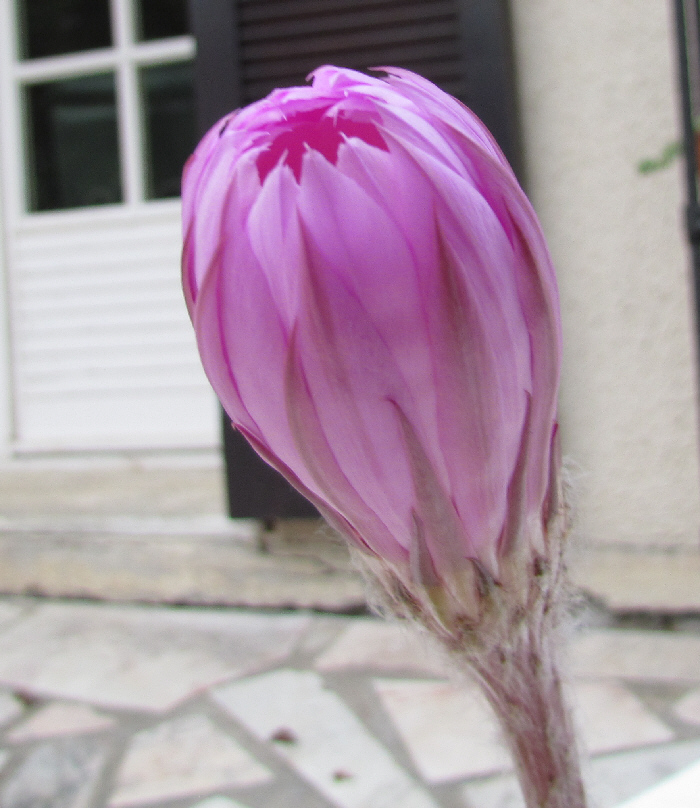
top-left (189, 0), bottom-right (520, 519)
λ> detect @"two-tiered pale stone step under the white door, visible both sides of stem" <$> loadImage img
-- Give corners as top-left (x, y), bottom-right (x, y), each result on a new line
top-left (0, 453), bottom-right (700, 615)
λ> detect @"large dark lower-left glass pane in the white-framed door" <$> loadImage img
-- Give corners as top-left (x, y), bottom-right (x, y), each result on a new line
top-left (26, 74), bottom-right (122, 210)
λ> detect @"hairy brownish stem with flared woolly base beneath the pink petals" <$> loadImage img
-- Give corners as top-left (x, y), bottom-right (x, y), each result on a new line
top-left (356, 492), bottom-right (586, 808)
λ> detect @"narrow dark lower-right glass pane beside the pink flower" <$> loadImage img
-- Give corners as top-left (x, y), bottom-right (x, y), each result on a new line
top-left (141, 62), bottom-right (195, 199)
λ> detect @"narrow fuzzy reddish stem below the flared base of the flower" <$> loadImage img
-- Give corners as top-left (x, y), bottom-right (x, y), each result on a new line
top-left (469, 620), bottom-right (586, 808)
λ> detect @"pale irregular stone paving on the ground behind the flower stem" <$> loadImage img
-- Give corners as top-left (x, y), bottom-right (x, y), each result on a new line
top-left (0, 598), bottom-right (700, 808)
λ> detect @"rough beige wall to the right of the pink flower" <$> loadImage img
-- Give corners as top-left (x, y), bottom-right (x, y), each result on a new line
top-left (512, 0), bottom-right (700, 545)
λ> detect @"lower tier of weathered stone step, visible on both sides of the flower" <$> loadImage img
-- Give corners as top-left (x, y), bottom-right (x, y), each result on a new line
top-left (0, 514), bottom-right (700, 615)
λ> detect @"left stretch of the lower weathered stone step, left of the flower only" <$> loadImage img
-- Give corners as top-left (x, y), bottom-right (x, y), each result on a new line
top-left (0, 520), bottom-right (365, 612)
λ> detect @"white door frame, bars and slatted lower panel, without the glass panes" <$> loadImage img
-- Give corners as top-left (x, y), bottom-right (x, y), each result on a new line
top-left (0, 0), bottom-right (219, 463)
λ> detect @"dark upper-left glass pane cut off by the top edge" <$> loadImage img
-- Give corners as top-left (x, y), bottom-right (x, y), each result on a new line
top-left (17, 0), bottom-right (112, 59)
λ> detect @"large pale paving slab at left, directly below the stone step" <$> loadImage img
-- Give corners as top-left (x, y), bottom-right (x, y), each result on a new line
top-left (0, 603), bottom-right (309, 712)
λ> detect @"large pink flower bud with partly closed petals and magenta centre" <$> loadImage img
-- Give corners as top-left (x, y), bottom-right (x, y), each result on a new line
top-left (182, 67), bottom-right (561, 587)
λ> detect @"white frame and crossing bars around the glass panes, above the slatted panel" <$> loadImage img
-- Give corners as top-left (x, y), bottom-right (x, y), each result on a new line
top-left (0, 0), bottom-right (195, 221)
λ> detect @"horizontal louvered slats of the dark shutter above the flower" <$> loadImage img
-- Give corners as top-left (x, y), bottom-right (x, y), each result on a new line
top-left (239, 0), bottom-right (464, 103)
